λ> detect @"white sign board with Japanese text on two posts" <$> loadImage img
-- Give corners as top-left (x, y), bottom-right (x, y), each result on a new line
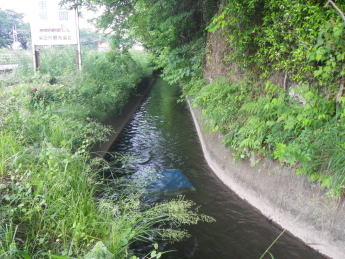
top-left (31, 0), bottom-right (78, 46)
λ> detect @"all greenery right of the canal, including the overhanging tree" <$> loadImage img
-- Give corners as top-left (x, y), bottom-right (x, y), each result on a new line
top-left (70, 0), bottom-right (345, 196)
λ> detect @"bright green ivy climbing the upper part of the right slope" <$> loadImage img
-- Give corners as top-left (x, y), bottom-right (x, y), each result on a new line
top-left (208, 0), bottom-right (345, 95)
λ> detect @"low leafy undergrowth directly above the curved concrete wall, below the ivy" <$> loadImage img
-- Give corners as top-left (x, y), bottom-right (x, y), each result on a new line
top-left (185, 78), bottom-right (345, 196)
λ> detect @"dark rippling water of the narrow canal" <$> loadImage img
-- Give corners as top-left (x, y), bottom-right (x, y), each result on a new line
top-left (107, 79), bottom-right (324, 259)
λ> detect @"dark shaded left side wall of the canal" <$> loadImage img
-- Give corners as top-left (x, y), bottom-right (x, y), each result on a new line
top-left (93, 74), bottom-right (156, 158)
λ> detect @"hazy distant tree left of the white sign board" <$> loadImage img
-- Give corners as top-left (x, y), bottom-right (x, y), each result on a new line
top-left (0, 9), bottom-right (30, 49)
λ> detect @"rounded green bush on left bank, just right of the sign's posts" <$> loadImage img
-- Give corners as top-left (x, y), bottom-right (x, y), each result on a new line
top-left (77, 51), bottom-right (143, 120)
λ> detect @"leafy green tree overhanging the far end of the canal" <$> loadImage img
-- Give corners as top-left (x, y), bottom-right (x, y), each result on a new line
top-left (64, 0), bottom-right (220, 85)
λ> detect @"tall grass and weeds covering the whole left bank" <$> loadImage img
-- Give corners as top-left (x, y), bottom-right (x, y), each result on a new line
top-left (0, 49), bottom-right (208, 258)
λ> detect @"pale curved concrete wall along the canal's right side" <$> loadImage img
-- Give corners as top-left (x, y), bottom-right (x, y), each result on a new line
top-left (189, 102), bottom-right (345, 259)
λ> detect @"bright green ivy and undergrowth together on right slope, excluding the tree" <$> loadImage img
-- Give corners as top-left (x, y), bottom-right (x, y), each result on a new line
top-left (191, 0), bottom-right (345, 196)
